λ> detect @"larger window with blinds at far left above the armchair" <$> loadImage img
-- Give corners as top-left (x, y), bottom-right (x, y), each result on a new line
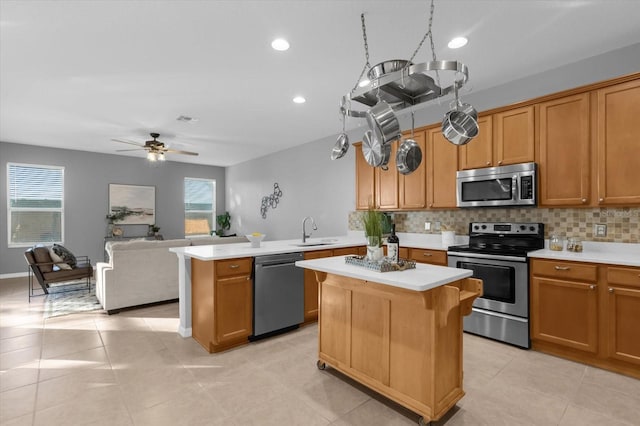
top-left (7, 163), bottom-right (64, 247)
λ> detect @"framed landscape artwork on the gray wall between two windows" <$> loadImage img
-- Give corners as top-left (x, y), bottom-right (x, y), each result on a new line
top-left (109, 183), bottom-right (156, 225)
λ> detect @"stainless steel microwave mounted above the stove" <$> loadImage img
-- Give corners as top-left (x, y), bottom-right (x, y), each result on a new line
top-left (456, 163), bottom-right (537, 207)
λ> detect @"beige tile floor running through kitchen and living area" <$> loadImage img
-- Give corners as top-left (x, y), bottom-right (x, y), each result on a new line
top-left (0, 279), bottom-right (640, 426)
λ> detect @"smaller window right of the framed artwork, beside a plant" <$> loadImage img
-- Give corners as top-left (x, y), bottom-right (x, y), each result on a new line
top-left (184, 178), bottom-right (216, 236)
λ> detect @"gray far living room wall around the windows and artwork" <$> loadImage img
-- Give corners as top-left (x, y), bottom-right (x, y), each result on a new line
top-left (0, 142), bottom-right (225, 275)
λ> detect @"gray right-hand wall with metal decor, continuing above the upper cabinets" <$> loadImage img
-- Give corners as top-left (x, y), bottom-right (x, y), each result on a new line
top-left (227, 43), bottom-right (640, 239)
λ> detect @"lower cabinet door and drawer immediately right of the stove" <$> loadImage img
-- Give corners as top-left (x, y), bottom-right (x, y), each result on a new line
top-left (531, 260), bottom-right (598, 354)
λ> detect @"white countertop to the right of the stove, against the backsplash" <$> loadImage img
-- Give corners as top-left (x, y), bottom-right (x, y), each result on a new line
top-left (528, 241), bottom-right (640, 266)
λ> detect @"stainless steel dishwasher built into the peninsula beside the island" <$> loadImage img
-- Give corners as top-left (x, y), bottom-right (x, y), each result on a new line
top-left (251, 253), bottom-right (304, 340)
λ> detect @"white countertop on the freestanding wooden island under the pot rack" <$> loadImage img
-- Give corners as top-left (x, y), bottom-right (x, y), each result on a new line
top-left (296, 256), bottom-right (473, 291)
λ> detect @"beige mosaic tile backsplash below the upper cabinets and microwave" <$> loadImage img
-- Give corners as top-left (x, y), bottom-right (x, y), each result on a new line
top-left (349, 207), bottom-right (640, 243)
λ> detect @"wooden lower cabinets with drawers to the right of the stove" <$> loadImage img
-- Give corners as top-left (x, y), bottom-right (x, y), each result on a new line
top-left (530, 259), bottom-right (640, 378)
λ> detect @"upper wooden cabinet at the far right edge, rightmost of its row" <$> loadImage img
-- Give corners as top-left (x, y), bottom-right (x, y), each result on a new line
top-left (596, 80), bottom-right (640, 205)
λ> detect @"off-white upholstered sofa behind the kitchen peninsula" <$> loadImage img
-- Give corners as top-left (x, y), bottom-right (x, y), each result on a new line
top-left (96, 237), bottom-right (247, 314)
